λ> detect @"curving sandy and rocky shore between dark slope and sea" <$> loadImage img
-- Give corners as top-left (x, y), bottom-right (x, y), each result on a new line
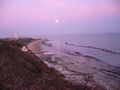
top-left (28, 40), bottom-right (120, 90)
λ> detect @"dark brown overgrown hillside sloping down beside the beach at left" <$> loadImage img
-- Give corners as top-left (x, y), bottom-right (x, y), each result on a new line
top-left (0, 39), bottom-right (103, 90)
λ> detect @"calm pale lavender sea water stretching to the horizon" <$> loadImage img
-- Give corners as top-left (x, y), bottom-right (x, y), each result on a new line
top-left (43, 34), bottom-right (120, 66)
